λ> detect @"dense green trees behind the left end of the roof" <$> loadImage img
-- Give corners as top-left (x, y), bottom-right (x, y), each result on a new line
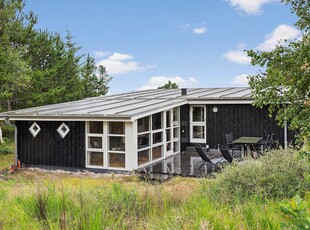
top-left (0, 0), bottom-right (111, 111)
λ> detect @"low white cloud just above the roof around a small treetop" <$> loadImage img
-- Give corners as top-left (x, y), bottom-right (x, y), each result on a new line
top-left (138, 76), bottom-right (198, 90)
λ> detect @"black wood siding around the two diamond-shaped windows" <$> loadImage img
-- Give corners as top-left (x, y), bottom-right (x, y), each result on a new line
top-left (16, 121), bottom-right (85, 168)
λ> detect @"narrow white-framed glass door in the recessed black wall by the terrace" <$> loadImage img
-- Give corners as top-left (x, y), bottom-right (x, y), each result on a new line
top-left (190, 105), bottom-right (206, 143)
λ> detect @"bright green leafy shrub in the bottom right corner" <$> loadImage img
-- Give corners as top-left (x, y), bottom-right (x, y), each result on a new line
top-left (280, 195), bottom-right (310, 230)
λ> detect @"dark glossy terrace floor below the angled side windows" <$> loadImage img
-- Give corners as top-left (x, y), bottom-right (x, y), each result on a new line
top-left (136, 147), bottom-right (232, 181)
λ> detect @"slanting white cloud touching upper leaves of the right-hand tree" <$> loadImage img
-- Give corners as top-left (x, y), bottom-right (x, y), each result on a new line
top-left (256, 24), bottom-right (301, 51)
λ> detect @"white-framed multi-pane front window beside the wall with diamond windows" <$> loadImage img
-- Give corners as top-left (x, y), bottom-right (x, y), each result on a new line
top-left (86, 121), bottom-right (126, 168)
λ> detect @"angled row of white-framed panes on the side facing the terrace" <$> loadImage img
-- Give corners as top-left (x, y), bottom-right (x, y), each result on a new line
top-left (137, 108), bottom-right (180, 165)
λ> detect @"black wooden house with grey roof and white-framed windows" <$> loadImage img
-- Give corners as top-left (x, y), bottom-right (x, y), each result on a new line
top-left (0, 87), bottom-right (293, 171)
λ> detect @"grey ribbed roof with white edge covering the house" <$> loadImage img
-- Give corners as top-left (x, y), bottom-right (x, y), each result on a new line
top-left (0, 87), bottom-right (253, 120)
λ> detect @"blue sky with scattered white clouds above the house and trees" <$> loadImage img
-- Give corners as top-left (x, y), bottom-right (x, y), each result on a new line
top-left (26, 0), bottom-right (300, 93)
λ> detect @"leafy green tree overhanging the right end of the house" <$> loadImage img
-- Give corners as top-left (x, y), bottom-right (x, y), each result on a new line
top-left (248, 0), bottom-right (310, 144)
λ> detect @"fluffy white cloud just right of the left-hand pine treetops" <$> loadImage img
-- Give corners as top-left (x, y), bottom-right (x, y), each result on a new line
top-left (97, 53), bottom-right (156, 74)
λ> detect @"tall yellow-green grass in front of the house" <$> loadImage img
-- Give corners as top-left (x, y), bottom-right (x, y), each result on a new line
top-left (0, 174), bottom-right (285, 229)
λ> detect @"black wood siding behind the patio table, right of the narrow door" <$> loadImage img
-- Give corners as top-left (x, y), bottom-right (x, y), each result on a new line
top-left (206, 105), bottom-right (294, 148)
